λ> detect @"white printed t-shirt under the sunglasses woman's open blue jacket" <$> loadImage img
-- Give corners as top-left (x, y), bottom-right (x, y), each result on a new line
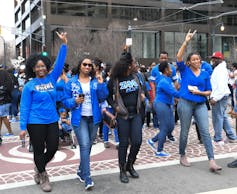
top-left (81, 82), bottom-right (93, 116)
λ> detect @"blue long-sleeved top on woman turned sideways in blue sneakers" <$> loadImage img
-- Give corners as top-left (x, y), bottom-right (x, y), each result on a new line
top-left (154, 75), bottom-right (179, 105)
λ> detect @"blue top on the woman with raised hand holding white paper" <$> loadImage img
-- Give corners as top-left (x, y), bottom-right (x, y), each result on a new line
top-left (177, 61), bottom-right (212, 103)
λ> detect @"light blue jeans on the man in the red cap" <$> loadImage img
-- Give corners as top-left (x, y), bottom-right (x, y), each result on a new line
top-left (212, 96), bottom-right (236, 141)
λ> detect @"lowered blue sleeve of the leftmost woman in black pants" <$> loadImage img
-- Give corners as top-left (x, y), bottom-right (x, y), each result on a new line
top-left (20, 85), bottom-right (32, 131)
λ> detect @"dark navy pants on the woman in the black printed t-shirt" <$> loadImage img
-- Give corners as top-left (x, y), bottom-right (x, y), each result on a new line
top-left (117, 114), bottom-right (142, 165)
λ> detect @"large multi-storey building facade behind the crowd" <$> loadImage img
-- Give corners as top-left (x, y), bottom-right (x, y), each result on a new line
top-left (15, 0), bottom-right (237, 62)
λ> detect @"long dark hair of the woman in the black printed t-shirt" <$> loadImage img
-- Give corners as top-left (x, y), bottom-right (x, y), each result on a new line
top-left (111, 52), bottom-right (133, 79)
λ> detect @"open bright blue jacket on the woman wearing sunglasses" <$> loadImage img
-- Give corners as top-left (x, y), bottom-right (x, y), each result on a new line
top-left (63, 75), bottom-right (109, 127)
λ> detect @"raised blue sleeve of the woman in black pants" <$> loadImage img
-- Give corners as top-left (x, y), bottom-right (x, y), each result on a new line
top-left (51, 44), bottom-right (67, 81)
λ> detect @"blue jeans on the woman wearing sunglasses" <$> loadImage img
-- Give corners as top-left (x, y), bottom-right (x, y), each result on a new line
top-left (73, 116), bottom-right (98, 180)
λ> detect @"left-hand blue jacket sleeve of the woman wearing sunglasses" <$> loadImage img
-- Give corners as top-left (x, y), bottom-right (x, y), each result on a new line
top-left (62, 81), bottom-right (77, 109)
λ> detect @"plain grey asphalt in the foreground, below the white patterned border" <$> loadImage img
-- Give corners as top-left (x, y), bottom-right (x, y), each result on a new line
top-left (1, 159), bottom-right (237, 194)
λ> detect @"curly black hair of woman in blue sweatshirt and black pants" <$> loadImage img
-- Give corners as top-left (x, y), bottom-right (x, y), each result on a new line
top-left (25, 54), bottom-right (52, 79)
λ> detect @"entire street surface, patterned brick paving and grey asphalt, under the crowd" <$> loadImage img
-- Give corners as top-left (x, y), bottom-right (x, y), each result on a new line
top-left (0, 113), bottom-right (237, 194)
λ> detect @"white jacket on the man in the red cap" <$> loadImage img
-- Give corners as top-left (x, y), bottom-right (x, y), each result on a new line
top-left (211, 61), bottom-right (230, 101)
